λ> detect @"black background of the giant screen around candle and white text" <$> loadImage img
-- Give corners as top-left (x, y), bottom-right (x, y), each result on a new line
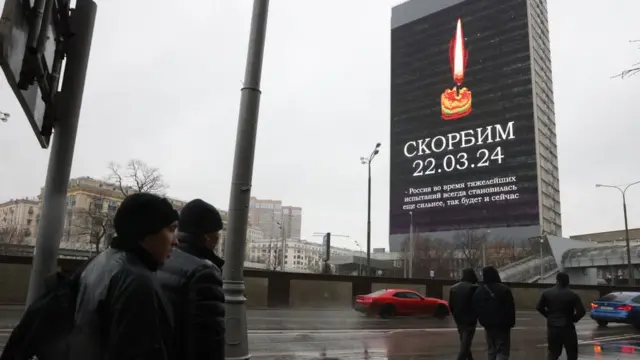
top-left (389, 0), bottom-right (539, 235)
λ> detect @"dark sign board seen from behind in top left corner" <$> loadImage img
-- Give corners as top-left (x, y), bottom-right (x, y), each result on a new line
top-left (0, 0), bottom-right (69, 148)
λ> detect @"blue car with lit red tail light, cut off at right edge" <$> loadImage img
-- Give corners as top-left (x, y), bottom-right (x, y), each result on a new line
top-left (591, 292), bottom-right (640, 329)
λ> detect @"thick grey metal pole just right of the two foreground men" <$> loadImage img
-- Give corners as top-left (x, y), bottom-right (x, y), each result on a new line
top-left (223, 0), bottom-right (269, 360)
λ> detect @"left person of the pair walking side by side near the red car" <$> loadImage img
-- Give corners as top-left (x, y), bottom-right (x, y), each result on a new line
top-left (449, 269), bottom-right (478, 360)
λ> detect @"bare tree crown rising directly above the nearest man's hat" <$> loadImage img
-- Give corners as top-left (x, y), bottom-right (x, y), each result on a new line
top-left (108, 159), bottom-right (167, 196)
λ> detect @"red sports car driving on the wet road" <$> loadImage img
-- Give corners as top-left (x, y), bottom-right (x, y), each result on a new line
top-left (354, 289), bottom-right (450, 319)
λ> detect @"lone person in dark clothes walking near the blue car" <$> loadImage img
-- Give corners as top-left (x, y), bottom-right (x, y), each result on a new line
top-left (536, 272), bottom-right (586, 360)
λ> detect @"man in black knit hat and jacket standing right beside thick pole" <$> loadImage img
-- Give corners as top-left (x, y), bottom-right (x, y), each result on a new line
top-left (158, 199), bottom-right (225, 360)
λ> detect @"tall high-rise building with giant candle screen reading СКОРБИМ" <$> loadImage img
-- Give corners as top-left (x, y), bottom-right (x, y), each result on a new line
top-left (389, 0), bottom-right (562, 251)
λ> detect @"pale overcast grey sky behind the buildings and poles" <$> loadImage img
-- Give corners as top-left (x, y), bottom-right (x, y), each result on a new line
top-left (0, 0), bottom-right (640, 247)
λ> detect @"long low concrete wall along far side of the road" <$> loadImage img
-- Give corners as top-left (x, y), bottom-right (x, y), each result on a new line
top-left (0, 256), bottom-right (640, 310)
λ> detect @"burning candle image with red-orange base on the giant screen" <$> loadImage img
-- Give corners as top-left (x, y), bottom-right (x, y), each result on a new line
top-left (440, 19), bottom-right (471, 120)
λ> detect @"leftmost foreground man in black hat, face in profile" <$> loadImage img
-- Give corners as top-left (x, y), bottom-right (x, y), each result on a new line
top-left (70, 193), bottom-right (178, 360)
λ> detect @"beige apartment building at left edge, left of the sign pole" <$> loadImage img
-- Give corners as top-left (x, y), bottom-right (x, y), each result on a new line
top-left (0, 198), bottom-right (39, 244)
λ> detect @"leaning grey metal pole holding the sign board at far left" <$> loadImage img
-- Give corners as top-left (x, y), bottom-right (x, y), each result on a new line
top-left (27, 0), bottom-right (97, 305)
